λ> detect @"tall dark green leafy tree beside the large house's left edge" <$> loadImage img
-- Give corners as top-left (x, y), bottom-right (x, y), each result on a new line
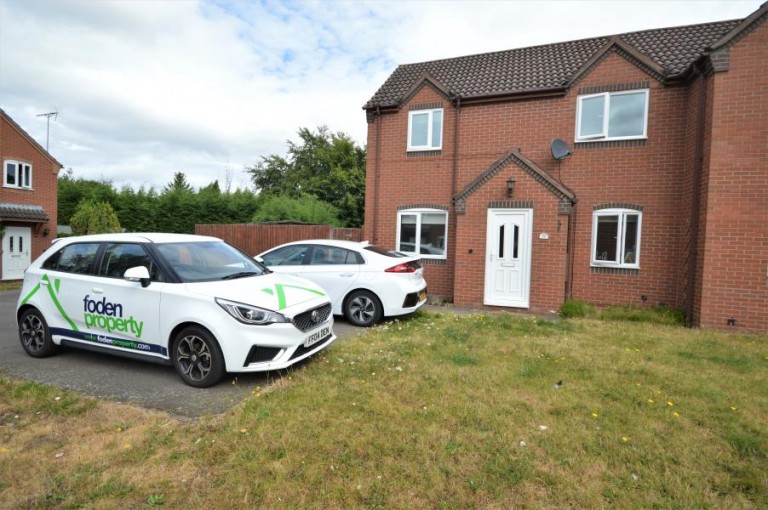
top-left (247, 126), bottom-right (365, 227)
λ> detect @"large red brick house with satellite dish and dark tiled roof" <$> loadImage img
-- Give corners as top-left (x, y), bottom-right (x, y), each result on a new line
top-left (363, 3), bottom-right (768, 332)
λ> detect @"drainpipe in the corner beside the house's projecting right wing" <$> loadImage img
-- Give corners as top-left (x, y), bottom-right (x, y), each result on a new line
top-left (685, 66), bottom-right (708, 326)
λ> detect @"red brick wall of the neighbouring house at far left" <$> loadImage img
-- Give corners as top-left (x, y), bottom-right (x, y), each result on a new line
top-left (0, 115), bottom-right (59, 270)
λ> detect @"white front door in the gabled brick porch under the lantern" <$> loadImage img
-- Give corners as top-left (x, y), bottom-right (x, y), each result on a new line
top-left (484, 209), bottom-right (533, 308)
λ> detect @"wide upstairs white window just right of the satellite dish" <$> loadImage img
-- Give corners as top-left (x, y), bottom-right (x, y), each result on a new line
top-left (576, 89), bottom-right (648, 142)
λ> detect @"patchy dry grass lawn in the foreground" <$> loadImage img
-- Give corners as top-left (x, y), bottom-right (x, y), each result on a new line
top-left (0, 313), bottom-right (768, 509)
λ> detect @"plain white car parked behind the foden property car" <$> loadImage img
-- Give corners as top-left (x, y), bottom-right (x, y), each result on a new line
top-left (256, 239), bottom-right (427, 326)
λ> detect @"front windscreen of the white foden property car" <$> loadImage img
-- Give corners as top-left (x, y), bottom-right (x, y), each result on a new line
top-left (155, 241), bottom-right (268, 283)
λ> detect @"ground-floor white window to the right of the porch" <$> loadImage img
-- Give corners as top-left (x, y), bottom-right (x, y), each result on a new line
top-left (592, 209), bottom-right (643, 269)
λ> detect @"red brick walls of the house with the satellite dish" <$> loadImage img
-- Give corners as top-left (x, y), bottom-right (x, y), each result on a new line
top-left (365, 37), bottom-right (768, 329)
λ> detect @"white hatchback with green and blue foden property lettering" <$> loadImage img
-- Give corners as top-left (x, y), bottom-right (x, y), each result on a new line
top-left (16, 234), bottom-right (336, 388)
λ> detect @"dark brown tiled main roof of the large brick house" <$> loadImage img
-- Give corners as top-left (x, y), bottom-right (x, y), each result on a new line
top-left (363, 20), bottom-right (744, 109)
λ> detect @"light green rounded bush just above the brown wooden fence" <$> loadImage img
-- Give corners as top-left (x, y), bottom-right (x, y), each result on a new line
top-left (253, 195), bottom-right (341, 227)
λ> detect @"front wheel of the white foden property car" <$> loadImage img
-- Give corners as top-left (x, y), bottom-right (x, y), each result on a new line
top-left (172, 326), bottom-right (225, 388)
